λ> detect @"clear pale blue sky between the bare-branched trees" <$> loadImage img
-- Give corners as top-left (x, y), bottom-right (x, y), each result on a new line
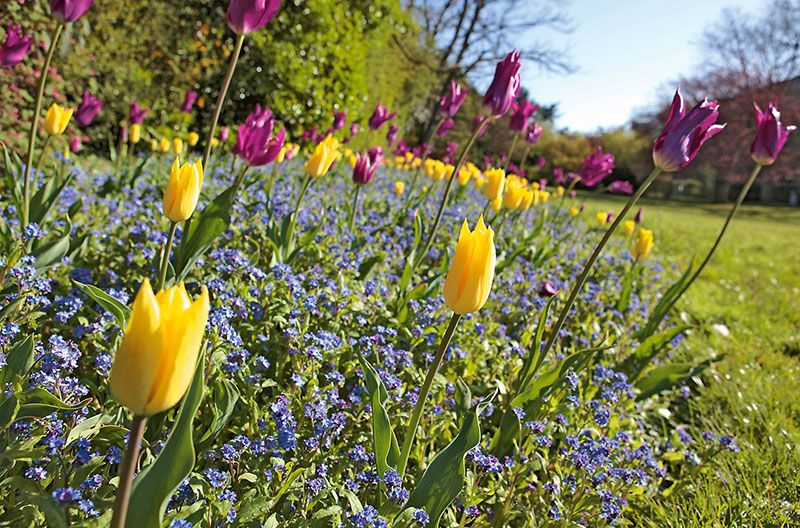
top-left (523, 0), bottom-right (766, 132)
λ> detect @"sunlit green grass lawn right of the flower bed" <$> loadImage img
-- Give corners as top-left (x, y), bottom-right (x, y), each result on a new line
top-left (586, 197), bottom-right (800, 526)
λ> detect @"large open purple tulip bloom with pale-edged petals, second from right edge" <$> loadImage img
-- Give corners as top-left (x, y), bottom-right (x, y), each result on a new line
top-left (653, 88), bottom-right (725, 172)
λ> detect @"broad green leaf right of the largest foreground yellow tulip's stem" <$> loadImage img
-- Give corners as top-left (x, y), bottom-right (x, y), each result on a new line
top-left (125, 354), bottom-right (205, 528)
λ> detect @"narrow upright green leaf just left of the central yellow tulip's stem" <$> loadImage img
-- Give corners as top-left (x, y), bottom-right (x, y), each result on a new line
top-left (358, 355), bottom-right (400, 475)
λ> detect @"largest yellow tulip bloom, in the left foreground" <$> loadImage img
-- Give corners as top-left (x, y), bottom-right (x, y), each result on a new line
top-left (109, 279), bottom-right (209, 416)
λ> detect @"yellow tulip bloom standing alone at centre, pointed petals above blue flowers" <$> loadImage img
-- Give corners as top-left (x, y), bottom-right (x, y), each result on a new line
top-left (444, 215), bottom-right (497, 315)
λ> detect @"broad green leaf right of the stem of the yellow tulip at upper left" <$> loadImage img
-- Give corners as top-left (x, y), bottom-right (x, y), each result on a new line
top-left (174, 184), bottom-right (236, 281)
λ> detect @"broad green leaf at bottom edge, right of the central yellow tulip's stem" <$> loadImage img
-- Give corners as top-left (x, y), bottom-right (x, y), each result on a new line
top-left (406, 392), bottom-right (496, 528)
